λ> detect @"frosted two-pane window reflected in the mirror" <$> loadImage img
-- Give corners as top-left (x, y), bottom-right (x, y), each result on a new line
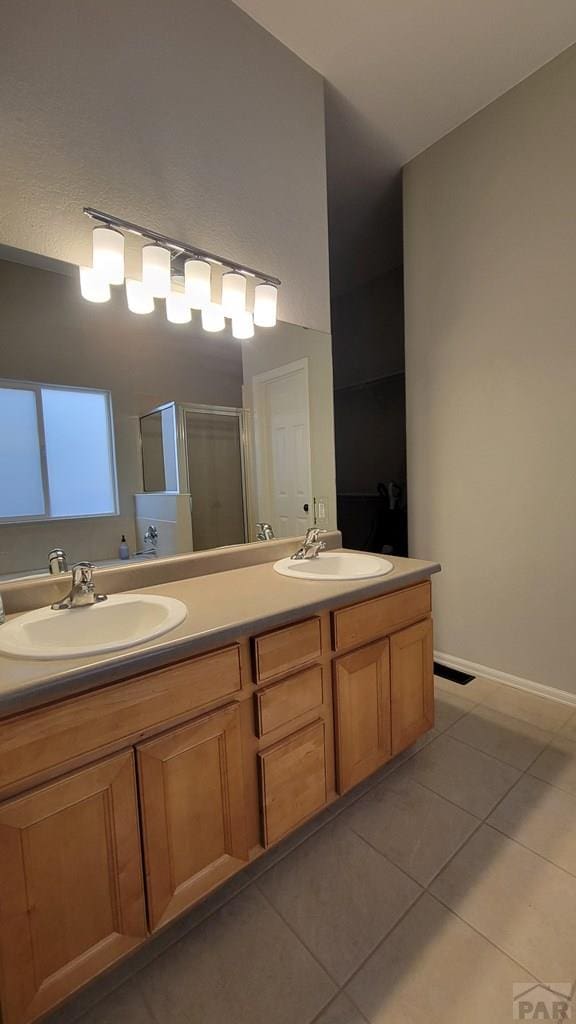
top-left (0, 381), bottom-right (118, 522)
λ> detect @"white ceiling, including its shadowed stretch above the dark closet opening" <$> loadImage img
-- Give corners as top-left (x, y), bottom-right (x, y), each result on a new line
top-left (230, 0), bottom-right (576, 290)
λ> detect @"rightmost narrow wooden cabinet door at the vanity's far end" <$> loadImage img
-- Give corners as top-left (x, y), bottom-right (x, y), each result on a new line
top-left (390, 618), bottom-right (434, 755)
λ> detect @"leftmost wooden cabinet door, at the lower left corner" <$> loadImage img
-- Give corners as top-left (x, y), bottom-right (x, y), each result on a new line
top-left (0, 753), bottom-right (147, 1024)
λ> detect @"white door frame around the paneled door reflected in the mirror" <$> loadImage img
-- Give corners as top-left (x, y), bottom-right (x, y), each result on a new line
top-left (251, 357), bottom-right (314, 540)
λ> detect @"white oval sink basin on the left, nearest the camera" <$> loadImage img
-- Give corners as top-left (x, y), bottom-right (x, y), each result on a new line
top-left (0, 594), bottom-right (188, 659)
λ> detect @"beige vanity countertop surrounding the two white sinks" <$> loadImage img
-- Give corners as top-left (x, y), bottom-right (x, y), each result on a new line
top-left (0, 555), bottom-right (440, 717)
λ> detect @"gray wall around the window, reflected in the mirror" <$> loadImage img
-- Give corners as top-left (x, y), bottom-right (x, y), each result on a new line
top-left (0, 261), bottom-right (242, 575)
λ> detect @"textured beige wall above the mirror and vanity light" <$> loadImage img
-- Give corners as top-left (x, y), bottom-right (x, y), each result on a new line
top-left (0, 0), bottom-right (330, 331)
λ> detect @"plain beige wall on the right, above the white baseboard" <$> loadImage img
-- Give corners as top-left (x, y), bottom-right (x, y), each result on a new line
top-left (404, 48), bottom-right (576, 693)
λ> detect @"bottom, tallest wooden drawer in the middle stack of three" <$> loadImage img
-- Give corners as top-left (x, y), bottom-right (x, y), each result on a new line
top-left (258, 721), bottom-right (326, 846)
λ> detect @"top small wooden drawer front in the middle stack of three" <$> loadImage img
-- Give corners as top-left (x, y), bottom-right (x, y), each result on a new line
top-left (254, 618), bottom-right (322, 683)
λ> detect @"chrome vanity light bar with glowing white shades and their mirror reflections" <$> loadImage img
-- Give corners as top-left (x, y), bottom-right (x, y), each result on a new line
top-left (80, 207), bottom-right (280, 339)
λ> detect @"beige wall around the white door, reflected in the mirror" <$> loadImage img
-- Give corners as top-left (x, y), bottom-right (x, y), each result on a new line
top-left (242, 324), bottom-right (336, 529)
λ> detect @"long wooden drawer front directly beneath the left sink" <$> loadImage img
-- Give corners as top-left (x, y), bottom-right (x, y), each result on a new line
top-left (0, 645), bottom-right (242, 791)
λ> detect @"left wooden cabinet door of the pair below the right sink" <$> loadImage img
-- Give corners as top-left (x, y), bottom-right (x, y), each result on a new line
top-left (334, 640), bottom-right (392, 793)
